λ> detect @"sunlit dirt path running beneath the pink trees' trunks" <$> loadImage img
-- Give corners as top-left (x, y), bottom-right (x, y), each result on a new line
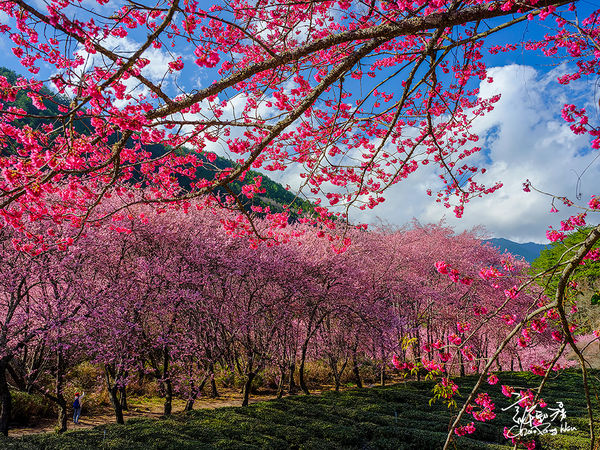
top-left (9, 392), bottom-right (275, 438)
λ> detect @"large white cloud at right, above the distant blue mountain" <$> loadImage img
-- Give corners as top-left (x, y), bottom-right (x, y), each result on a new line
top-left (344, 65), bottom-right (600, 242)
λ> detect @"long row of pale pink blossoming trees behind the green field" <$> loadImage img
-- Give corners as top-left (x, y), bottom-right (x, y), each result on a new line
top-left (0, 207), bottom-right (564, 433)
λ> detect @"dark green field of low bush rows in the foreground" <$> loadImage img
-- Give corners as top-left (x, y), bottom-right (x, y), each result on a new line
top-left (0, 372), bottom-right (600, 450)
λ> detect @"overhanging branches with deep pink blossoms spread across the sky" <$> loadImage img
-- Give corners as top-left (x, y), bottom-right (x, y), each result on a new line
top-left (0, 0), bottom-right (597, 248)
